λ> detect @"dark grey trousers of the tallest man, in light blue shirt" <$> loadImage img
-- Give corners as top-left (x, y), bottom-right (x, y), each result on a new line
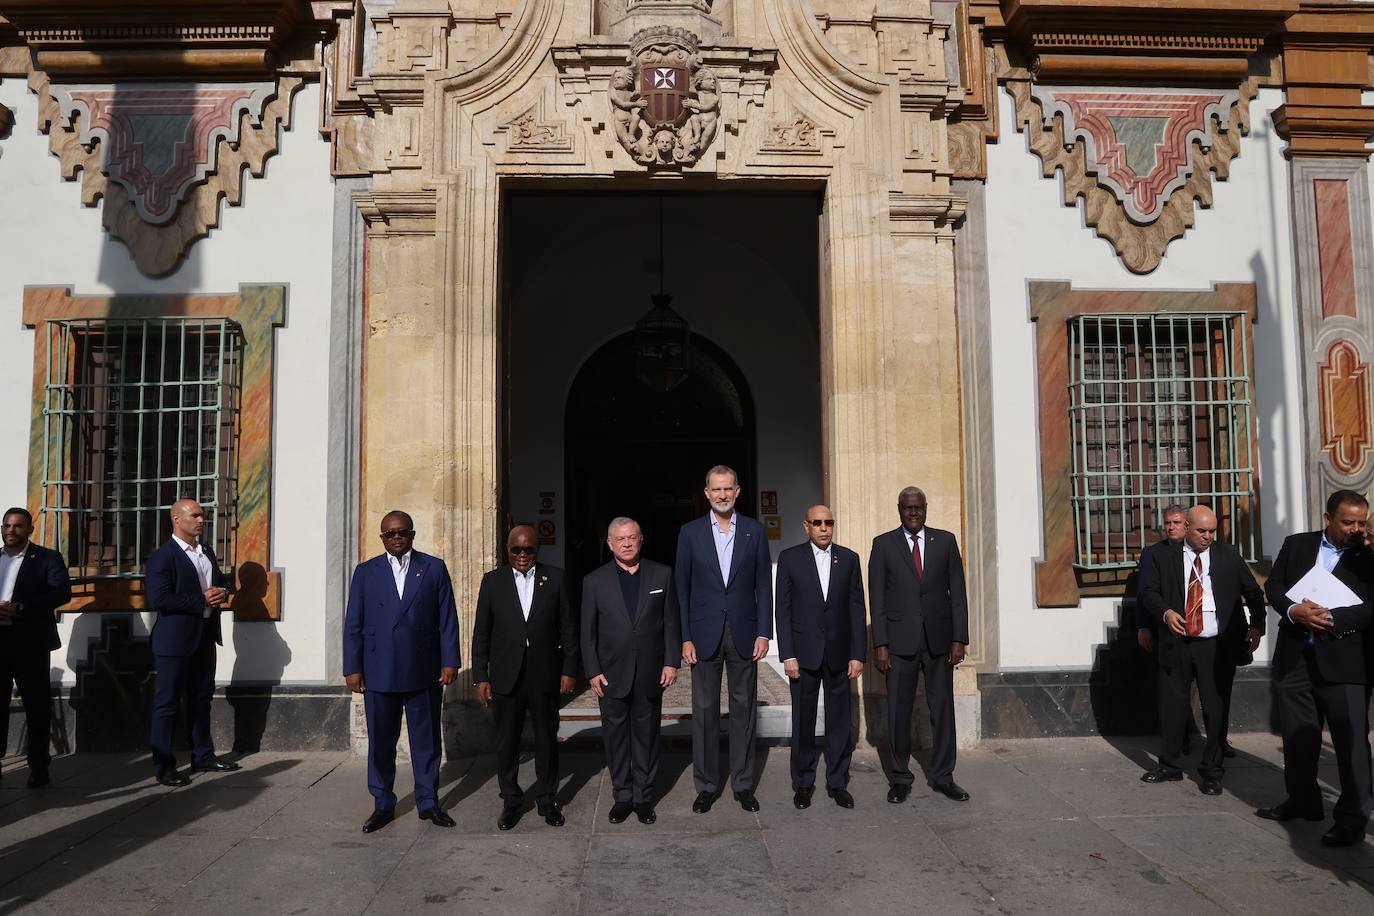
top-left (691, 622), bottom-right (758, 795)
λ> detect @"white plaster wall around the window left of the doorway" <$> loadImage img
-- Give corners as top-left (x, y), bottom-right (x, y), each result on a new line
top-left (0, 80), bottom-right (341, 683)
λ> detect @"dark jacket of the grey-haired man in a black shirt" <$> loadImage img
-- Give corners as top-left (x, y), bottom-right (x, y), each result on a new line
top-left (581, 560), bottom-right (683, 699)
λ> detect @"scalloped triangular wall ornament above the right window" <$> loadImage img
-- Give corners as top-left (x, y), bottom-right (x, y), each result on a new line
top-left (1007, 80), bottom-right (1254, 273)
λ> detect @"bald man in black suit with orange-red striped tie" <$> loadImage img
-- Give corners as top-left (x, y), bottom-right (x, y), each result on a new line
top-left (1140, 505), bottom-right (1264, 795)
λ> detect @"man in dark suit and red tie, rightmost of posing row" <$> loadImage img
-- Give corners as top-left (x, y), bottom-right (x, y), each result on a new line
top-left (868, 486), bottom-right (969, 805)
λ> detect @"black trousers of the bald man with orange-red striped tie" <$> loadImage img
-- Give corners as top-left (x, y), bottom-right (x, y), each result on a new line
top-left (1160, 636), bottom-right (1235, 779)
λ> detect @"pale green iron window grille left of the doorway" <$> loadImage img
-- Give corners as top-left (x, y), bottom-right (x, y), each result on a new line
top-left (40, 317), bottom-right (243, 582)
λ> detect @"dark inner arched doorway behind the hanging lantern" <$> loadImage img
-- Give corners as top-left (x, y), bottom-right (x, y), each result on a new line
top-left (563, 334), bottom-right (757, 577)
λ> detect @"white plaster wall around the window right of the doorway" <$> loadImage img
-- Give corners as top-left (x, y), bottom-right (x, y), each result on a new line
top-left (987, 89), bottom-right (1297, 670)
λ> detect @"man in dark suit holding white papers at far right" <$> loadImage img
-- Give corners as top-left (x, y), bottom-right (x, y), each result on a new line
top-left (1254, 490), bottom-right (1374, 846)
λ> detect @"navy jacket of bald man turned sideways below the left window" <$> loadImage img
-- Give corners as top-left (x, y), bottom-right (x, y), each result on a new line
top-left (143, 537), bottom-right (225, 655)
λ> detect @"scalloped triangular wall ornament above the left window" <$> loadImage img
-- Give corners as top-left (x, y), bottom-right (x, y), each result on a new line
top-left (29, 71), bottom-right (304, 276)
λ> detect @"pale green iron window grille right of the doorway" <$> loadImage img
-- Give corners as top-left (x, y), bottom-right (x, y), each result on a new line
top-left (1069, 313), bottom-right (1259, 570)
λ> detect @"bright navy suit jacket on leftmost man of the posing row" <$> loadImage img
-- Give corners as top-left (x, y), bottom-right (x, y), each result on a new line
top-left (344, 549), bottom-right (462, 694)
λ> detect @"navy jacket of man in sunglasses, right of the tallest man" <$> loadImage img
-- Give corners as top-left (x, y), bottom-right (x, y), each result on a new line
top-left (778, 541), bottom-right (868, 670)
